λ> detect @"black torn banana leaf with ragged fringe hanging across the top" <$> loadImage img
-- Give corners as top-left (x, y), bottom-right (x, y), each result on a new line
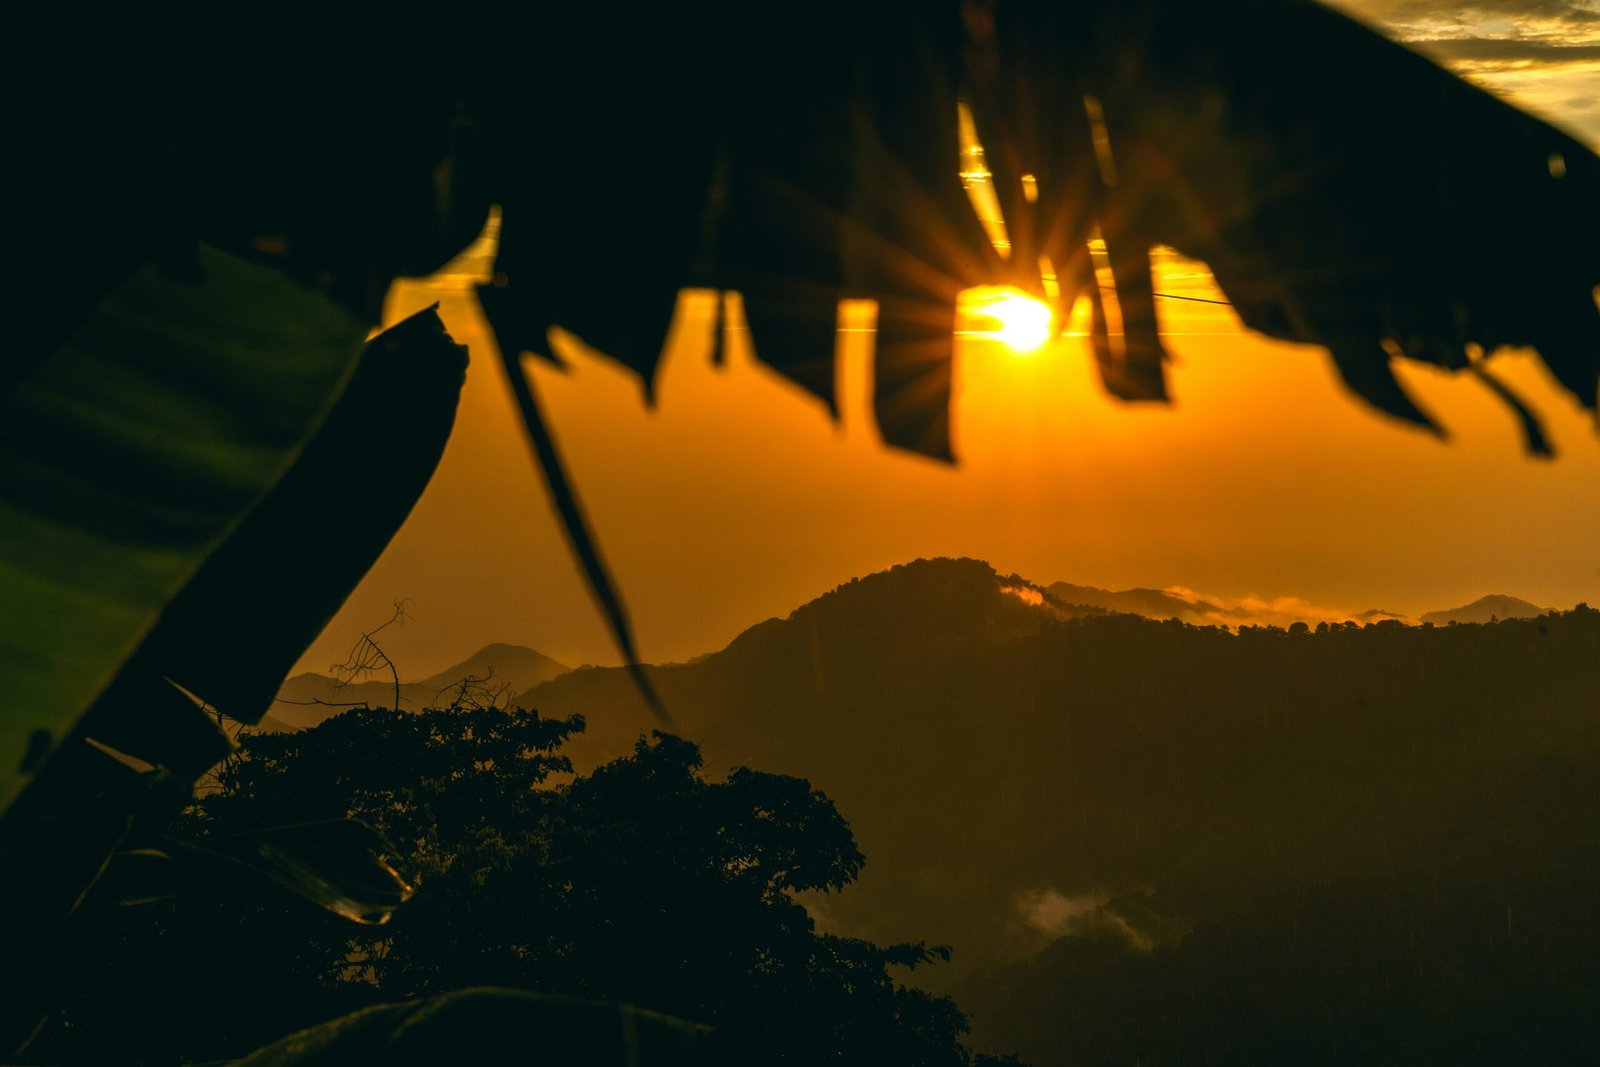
top-left (0, 0), bottom-right (1600, 751)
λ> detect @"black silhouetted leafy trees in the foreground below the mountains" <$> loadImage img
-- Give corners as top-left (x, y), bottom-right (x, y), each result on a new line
top-left (32, 709), bottom-right (1017, 1064)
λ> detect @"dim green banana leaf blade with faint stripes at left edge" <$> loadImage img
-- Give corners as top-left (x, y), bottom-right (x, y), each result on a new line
top-left (0, 248), bottom-right (363, 805)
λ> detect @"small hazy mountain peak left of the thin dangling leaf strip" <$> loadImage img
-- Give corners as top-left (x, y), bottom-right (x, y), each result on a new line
top-left (270, 645), bottom-right (570, 731)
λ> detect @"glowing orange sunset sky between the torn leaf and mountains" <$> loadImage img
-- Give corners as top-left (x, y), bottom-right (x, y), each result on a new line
top-left (291, 10), bottom-right (1600, 677)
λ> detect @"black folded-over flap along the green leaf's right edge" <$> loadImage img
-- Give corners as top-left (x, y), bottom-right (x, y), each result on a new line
top-left (85, 307), bottom-right (467, 729)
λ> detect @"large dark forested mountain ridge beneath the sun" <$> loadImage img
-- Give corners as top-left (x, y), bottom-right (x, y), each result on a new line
top-left (518, 560), bottom-right (1600, 1067)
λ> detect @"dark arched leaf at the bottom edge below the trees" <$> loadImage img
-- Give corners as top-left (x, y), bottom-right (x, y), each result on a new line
top-left (235, 987), bottom-right (709, 1067)
